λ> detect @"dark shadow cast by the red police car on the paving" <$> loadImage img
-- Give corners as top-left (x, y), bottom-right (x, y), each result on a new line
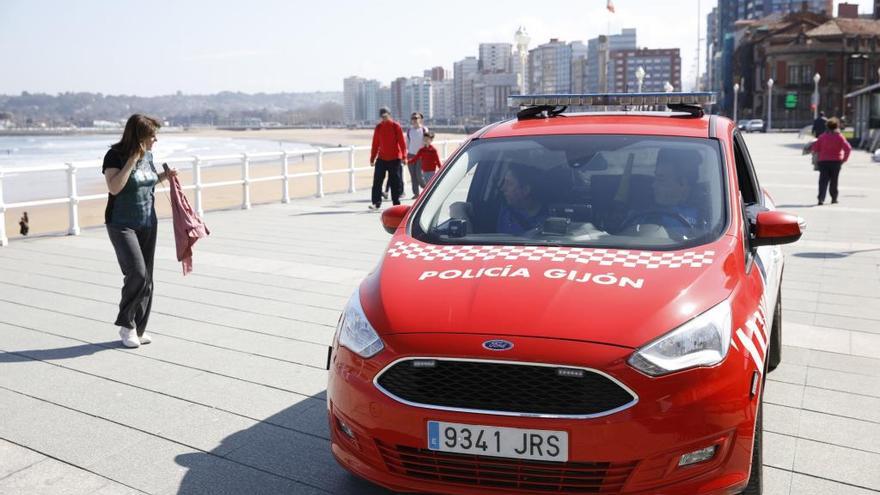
top-left (175, 392), bottom-right (393, 495)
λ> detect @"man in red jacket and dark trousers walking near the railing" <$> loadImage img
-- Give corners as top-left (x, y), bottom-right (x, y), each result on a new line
top-left (370, 107), bottom-right (406, 210)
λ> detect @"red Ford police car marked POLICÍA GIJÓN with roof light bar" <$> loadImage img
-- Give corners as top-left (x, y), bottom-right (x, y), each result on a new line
top-left (328, 93), bottom-right (803, 495)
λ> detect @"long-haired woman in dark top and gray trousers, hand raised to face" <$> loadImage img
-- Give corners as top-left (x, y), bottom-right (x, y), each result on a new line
top-left (102, 114), bottom-right (177, 347)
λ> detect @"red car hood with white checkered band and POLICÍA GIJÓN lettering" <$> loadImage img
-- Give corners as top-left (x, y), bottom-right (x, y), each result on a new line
top-left (360, 235), bottom-right (737, 348)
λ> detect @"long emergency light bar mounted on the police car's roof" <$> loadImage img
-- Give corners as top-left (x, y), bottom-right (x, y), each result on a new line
top-left (507, 92), bottom-right (715, 108)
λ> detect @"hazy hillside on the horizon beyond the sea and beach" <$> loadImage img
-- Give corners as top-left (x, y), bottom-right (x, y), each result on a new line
top-left (0, 92), bottom-right (343, 127)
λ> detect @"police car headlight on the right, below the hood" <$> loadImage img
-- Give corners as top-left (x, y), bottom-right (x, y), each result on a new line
top-left (629, 300), bottom-right (731, 376)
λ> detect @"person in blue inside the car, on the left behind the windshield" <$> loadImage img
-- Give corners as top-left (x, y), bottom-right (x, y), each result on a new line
top-left (496, 163), bottom-right (547, 236)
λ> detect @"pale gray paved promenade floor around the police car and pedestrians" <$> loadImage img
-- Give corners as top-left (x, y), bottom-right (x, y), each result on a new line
top-left (0, 134), bottom-right (880, 495)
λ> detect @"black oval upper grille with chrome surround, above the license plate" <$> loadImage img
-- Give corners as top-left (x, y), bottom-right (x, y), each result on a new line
top-left (376, 358), bottom-right (636, 417)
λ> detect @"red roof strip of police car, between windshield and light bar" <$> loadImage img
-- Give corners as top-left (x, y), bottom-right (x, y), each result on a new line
top-left (478, 112), bottom-right (710, 139)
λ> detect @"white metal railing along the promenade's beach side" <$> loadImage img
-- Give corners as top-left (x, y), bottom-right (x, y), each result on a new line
top-left (0, 139), bottom-right (464, 246)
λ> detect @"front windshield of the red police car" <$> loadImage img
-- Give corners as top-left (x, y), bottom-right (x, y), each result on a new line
top-left (412, 135), bottom-right (726, 249)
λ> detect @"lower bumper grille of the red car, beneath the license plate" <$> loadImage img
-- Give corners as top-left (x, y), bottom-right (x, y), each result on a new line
top-left (376, 440), bottom-right (636, 495)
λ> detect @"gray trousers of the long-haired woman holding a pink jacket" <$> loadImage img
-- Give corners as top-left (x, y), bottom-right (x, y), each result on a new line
top-left (107, 224), bottom-right (157, 336)
